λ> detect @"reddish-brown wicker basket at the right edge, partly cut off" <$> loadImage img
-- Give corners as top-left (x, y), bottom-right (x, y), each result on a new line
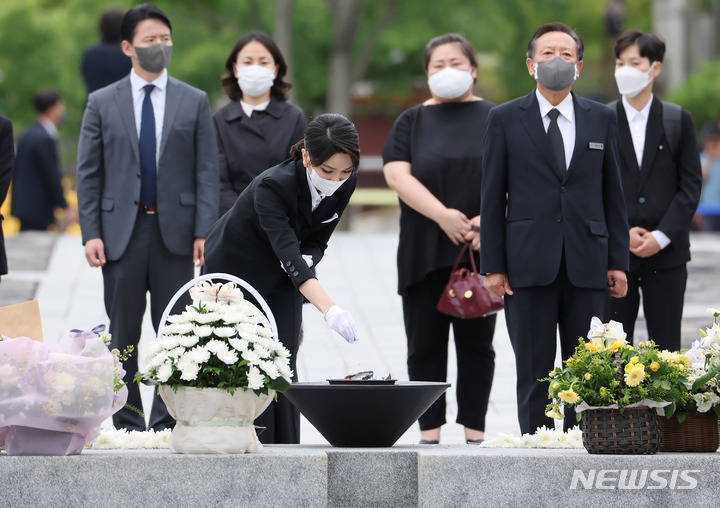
top-left (657, 413), bottom-right (720, 452)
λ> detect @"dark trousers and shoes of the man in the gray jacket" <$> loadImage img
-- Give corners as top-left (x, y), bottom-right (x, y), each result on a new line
top-left (103, 213), bottom-right (193, 431)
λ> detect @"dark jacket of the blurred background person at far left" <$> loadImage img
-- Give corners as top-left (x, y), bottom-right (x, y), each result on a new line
top-left (12, 123), bottom-right (67, 229)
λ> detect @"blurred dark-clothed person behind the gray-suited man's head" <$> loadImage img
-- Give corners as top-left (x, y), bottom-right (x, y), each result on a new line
top-left (82, 8), bottom-right (132, 95)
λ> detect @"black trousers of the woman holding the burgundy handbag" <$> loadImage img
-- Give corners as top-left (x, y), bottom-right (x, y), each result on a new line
top-left (402, 268), bottom-right (496, 431)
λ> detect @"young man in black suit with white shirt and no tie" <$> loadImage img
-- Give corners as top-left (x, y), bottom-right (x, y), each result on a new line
top-left (606, 30), bottom-right (702, 351)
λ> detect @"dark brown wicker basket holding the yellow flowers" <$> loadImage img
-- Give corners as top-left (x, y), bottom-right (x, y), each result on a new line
top-left (582, 407), bottom-right (660, 455)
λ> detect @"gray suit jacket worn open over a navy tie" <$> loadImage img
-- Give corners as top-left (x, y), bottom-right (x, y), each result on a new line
top-left (77, 76), bottom-right (219, 261)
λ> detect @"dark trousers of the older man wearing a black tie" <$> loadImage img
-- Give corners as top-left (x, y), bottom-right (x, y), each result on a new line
top-left (505, 262), bottom-right (607, 434)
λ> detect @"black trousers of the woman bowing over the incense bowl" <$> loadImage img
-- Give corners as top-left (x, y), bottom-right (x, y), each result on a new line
top-left (253, 280), bottom-right (303, 444)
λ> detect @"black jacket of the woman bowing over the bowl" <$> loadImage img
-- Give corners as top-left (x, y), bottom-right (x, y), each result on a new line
top-left (205, 159), bottom-right (357, 297)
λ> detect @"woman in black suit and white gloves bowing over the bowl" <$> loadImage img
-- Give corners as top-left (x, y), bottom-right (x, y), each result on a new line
top-left (205, 114), bottom-right (360, 444)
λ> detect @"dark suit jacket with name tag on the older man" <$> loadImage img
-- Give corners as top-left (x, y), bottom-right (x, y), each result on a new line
top-left (480, 90), bottom-right (629, 288)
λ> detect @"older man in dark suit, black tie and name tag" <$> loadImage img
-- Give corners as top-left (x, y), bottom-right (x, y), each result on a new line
top-left (480, 23), bottom-right (628, 433)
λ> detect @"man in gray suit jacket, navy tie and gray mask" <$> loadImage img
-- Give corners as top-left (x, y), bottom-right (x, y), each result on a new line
top-left (77, 4), bottom-right (219, 430)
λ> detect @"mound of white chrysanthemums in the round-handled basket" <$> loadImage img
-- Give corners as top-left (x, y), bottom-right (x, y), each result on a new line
top-left (136, 281), bottom-right (293, 395)
